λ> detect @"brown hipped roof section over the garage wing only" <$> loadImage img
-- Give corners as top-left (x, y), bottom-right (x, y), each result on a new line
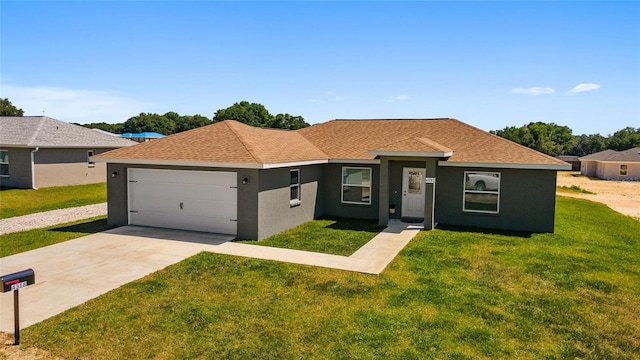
top-left (95, 120), bottom-right (327, 164)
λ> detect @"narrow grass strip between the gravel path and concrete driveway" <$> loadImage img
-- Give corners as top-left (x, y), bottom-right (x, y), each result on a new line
top-left (0, 216), bottom-right (110, 258)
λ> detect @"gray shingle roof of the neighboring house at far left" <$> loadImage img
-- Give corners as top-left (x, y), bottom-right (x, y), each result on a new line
top-left (0, 116), bottom-right (137, 148)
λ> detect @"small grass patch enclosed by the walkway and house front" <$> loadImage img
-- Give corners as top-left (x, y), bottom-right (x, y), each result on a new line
top-left (246, 218), bottom-right (385, 256)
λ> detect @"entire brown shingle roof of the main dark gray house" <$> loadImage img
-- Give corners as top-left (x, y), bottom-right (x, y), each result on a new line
top-left (96, 119), bottom-right (567, 166)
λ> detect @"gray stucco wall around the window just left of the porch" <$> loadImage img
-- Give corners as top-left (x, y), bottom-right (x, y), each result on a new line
top-left (321, 164), bottom-right (380, 219)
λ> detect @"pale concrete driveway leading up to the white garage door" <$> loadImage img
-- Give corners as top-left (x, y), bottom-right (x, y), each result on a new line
top-left (0, 227), bottom-right (234, 333)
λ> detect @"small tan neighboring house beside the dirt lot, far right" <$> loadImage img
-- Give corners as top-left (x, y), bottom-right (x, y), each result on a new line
top-left (580, 147), bottom-right (640, 180)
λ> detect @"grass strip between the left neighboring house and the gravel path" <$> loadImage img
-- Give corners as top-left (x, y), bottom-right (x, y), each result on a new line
top-left (0, 183), bottom-right (107, 219)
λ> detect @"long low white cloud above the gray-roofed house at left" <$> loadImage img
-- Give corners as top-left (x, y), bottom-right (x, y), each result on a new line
top-left (0, 85), bottom-right (154, 124)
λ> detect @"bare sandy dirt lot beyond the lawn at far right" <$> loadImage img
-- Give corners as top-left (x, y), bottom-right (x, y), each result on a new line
top-left (558, 171), bottom-right (640, 219)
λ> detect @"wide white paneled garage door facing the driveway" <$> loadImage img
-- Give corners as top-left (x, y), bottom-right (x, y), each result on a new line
top-left (127, 169), bottom-right (238, 235)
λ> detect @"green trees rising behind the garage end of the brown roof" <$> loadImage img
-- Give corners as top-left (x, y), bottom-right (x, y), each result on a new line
top-left (83, 101), bottom-right (309, 135)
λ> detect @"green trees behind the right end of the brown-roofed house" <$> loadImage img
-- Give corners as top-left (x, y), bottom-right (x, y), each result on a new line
top-left (490, 122), bottom-right (640, 156)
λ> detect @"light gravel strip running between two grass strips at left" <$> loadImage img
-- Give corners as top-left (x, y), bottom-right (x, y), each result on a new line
top-left (0, 203), bottom-right (107, 235)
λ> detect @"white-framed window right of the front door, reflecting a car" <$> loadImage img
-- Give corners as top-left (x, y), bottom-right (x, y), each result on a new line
top-left (462, 171), bottom-right (500, 214)
